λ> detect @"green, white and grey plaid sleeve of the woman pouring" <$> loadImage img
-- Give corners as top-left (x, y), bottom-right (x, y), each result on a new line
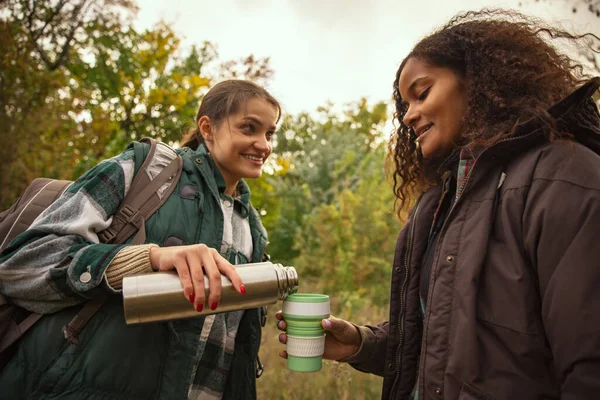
top-left (0, 147), bottom-right (135, 314)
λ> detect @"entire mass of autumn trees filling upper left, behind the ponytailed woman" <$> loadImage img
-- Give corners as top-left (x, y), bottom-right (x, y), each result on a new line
top-left (0, 0), bottom-right (272, 208)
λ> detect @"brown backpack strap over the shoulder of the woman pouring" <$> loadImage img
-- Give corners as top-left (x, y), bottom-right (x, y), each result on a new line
top-left (99, 138), bottom-right (183, 244)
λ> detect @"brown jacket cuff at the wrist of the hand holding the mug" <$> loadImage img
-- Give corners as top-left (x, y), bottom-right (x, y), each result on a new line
top-left (339, 322), bottom-right (389, 376)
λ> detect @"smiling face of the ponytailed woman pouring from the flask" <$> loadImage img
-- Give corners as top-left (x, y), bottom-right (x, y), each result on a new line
top-left (198, 97), bottom-right (278, 195)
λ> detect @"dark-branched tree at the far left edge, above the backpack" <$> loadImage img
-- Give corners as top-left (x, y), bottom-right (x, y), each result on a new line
top-left (0, 0), bottom-right (135, 207)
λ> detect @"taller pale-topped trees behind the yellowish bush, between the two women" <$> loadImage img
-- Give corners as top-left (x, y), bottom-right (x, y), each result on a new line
top-left (253, 100), bottom-right (392, 264)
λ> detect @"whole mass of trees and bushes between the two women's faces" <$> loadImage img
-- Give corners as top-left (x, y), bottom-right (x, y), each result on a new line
top-left (250, 99), bottom-right (401, 309)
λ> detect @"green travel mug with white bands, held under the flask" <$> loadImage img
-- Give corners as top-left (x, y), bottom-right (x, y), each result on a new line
top-left (282, 293), bottom-right (329, 372)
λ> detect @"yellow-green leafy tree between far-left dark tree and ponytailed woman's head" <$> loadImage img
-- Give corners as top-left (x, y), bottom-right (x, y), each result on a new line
top-left (70, 20), bottom-right (215, 158)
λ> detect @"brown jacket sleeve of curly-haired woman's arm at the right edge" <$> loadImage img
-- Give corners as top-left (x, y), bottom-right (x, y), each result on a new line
top-left (523, 167), bottom-right (600, 400)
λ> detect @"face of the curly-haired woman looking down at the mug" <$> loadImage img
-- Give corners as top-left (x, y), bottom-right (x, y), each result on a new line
top-left (398, 57), bottom-right (467, 158)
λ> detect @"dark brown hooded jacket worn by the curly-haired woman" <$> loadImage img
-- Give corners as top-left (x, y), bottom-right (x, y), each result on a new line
top-left (351, 79), bottom-right (600, 400)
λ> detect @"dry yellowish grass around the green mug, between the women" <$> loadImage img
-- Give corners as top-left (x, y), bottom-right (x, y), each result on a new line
top-left (256, 283), bottom-right (388, 400)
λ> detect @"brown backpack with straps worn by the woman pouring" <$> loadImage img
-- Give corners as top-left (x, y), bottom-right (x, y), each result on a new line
top-left (0, 138), bottom-right (182, 369)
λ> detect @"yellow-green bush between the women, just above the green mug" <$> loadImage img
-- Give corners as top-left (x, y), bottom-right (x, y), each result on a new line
top-left (295, 154), bottom-right (400, 306)
